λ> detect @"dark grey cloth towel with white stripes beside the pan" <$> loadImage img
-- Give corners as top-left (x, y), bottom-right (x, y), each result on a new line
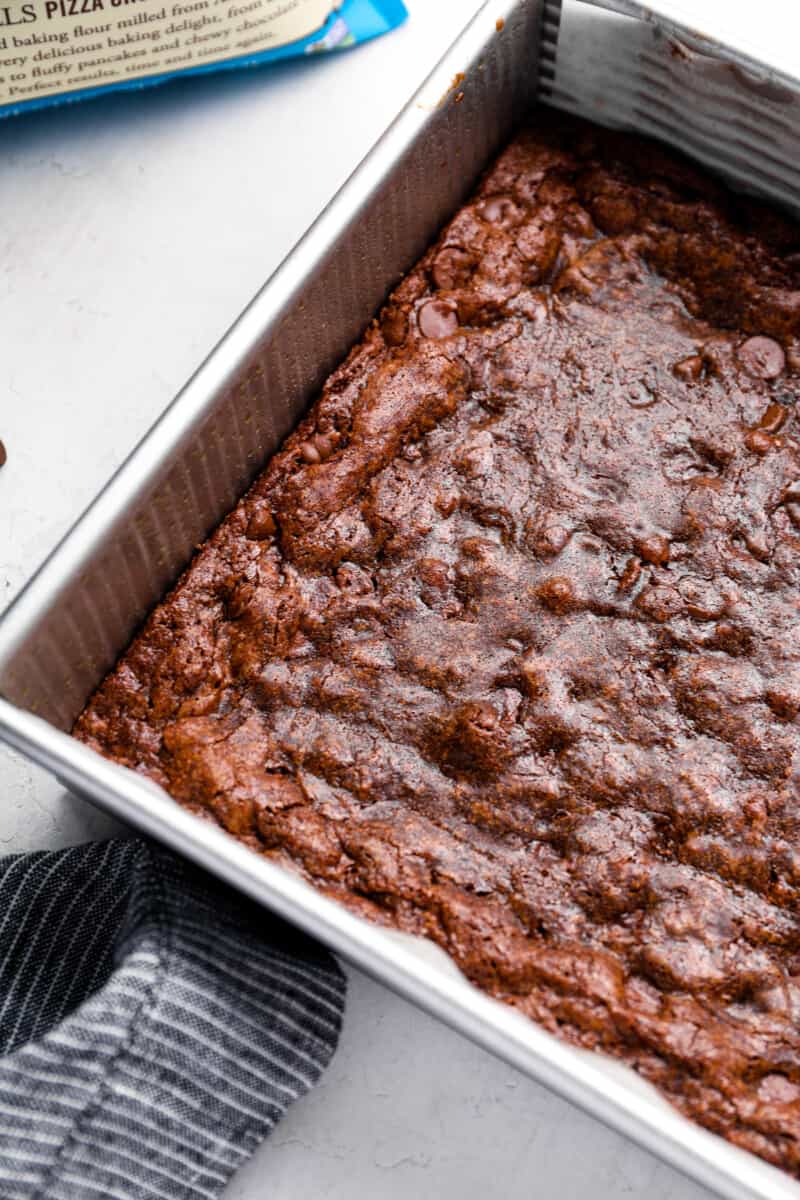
top-left (0, 840), bottom-right (344, 1200)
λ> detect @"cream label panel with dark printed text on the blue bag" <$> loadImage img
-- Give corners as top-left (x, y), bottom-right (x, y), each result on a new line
top-left (0, 0), bottom-right (337, 104)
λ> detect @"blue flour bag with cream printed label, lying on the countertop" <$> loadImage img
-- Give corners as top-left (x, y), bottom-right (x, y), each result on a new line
top-left (0, 0), bottom-right (405, 116)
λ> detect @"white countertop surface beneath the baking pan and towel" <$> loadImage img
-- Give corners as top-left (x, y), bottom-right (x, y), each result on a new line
top-left (0, 0), bottom-right (762, 1200)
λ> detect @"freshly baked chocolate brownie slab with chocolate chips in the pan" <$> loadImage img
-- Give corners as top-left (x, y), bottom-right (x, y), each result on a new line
top-left (76, 114), bottom-right (800, 1177)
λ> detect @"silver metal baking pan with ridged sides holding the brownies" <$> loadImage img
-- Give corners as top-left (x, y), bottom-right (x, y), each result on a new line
top-left (0, 0), bottom-right (800, 1200)
